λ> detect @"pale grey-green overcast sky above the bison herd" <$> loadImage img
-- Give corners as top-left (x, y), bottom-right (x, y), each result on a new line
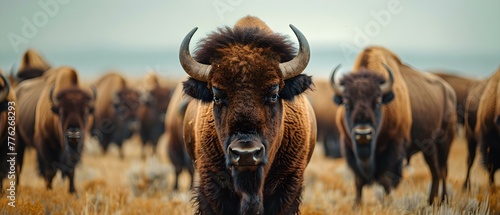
top-left (0, 0), bottom-right (500, 76)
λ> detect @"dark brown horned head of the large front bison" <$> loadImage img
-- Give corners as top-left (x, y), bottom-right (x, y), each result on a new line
top-left (179, 25), bottom-right (312, 175)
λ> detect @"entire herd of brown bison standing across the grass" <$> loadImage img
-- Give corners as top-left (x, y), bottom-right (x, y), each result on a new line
top-left (0, 16), bottom-right (500, 214)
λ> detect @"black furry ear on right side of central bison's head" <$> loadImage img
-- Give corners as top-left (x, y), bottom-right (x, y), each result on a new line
top-left (280, 74), bottom-right (312, 101)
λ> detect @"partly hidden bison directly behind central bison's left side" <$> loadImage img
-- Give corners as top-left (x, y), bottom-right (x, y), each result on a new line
top-left (165, 84), bottom-right (194, 190)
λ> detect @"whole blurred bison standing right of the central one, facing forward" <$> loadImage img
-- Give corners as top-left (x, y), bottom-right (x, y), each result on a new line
top-left (331, 47), bottom-right (456, 204)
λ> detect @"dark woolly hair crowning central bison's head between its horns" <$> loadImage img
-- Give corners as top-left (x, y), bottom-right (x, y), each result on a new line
top-left (194, 27), bottom-right (296, 64)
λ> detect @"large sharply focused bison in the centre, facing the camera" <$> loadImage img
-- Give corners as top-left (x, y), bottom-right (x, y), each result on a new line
top-left (179, 16), bottom-right (316, 214)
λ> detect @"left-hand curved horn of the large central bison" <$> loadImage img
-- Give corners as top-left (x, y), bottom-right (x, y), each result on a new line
top-left (179, 27), bottom-right (212, 82)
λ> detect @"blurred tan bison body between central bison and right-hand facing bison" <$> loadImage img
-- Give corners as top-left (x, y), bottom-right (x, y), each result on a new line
top-left (309, 79), bottom-right (342, 158)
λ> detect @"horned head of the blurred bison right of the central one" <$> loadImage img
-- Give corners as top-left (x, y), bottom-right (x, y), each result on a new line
top-left (331, 65), bottom-right (394, 178)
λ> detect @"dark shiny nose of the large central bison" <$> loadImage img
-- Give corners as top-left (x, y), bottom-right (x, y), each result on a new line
top-left (229, 146), bottom-right (265, 166)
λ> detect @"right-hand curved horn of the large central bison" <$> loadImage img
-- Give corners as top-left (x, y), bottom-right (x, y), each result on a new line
top-left (280, 25), bottom-right (311, 80)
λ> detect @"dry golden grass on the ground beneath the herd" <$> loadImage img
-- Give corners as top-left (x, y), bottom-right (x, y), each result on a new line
top-left (0, 133), bottom-right (500, 215)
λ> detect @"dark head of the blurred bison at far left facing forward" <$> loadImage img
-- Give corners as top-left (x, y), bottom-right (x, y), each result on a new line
top-left (49, 85), bottom-right (97, 157)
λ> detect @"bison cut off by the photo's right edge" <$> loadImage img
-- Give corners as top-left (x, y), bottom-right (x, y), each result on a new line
top-left (464, 68), bottom-right (500, 186)
